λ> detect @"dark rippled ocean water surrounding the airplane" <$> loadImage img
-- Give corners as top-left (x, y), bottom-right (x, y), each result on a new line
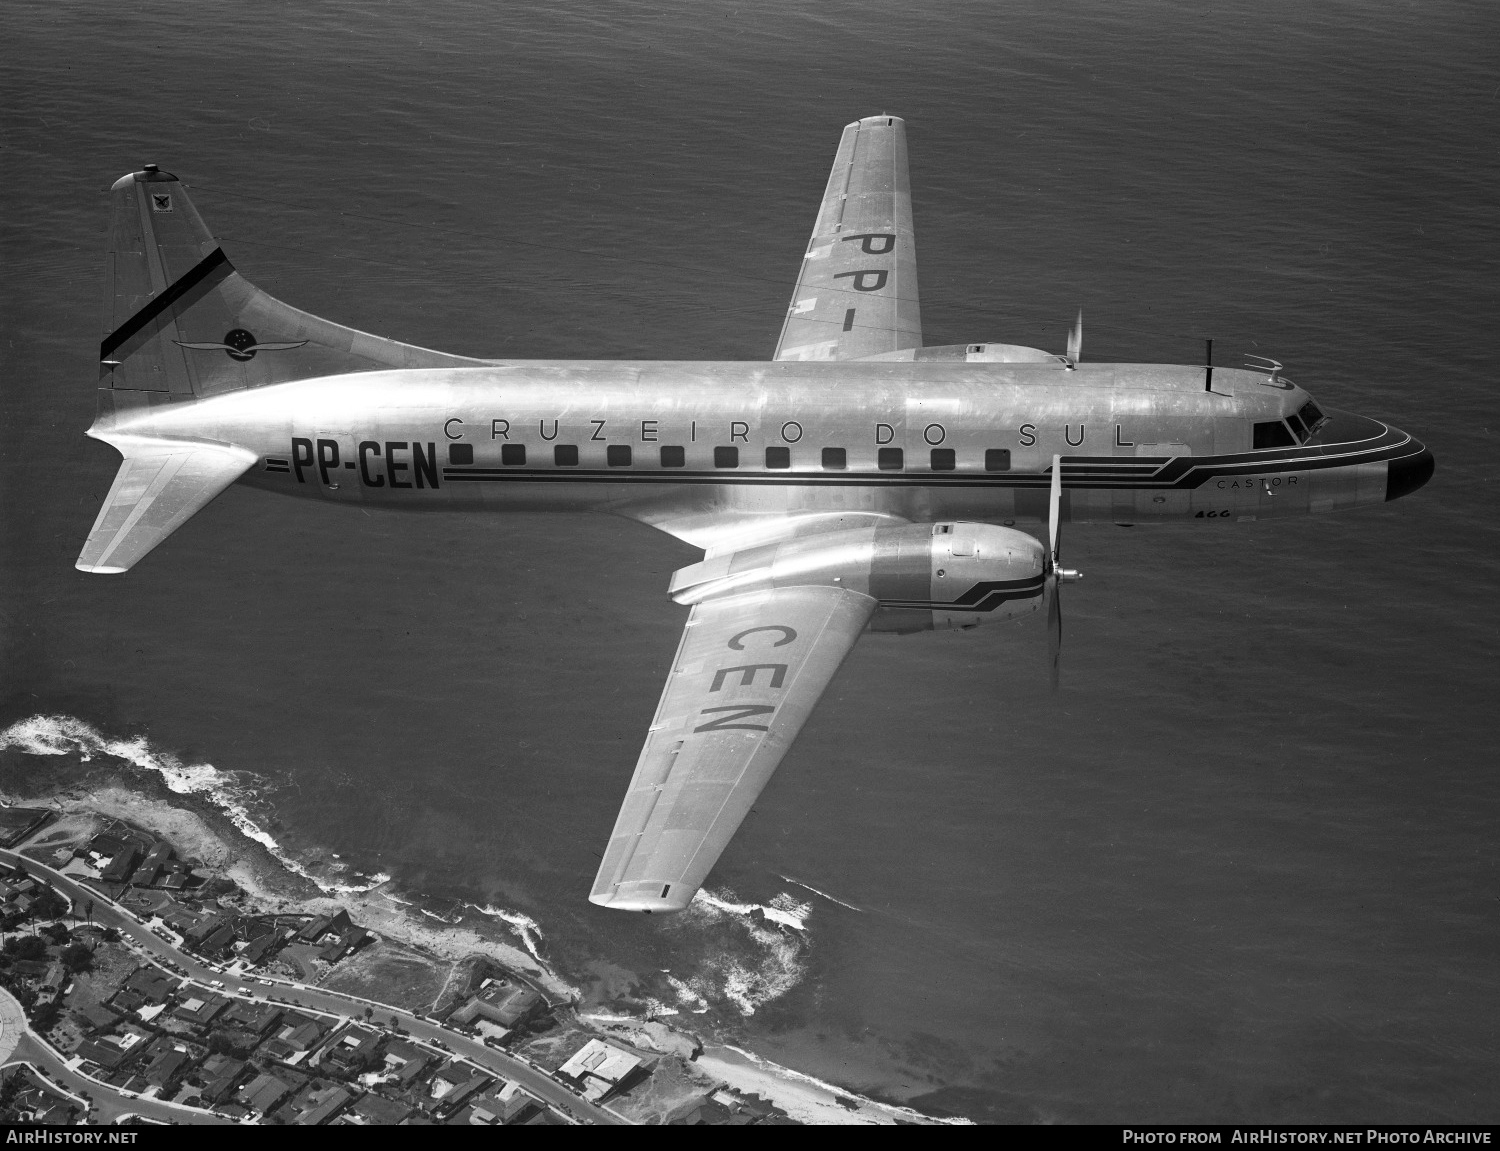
top-left (0, 0), bottom-right (1500, 1121)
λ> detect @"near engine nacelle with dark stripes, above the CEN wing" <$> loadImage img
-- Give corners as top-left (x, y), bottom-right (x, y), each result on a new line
top-left (672, 522), bottom-right (1046, 632)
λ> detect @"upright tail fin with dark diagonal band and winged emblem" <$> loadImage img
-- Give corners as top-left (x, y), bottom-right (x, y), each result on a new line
top-left (99, 164), bottom-right (483, 410)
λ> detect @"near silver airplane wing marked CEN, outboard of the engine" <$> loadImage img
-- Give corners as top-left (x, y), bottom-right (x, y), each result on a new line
top-left (590, 587), bottom-right (876, 911)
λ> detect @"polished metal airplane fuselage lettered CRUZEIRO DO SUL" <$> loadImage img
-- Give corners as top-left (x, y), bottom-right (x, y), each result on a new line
top-left (92, 360), bottom-right (1424, 546)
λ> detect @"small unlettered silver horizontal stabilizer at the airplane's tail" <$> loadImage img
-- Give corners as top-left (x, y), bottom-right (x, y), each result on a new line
top-left (74, 437), bottom-right (257, 575)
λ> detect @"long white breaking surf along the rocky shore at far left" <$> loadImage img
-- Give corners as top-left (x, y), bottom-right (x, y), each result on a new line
top-left (0, 716), bottom-right (390, 896)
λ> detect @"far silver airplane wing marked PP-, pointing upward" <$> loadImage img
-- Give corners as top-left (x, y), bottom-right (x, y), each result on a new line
top-left (773, 116), bottom-right (923, 360)
